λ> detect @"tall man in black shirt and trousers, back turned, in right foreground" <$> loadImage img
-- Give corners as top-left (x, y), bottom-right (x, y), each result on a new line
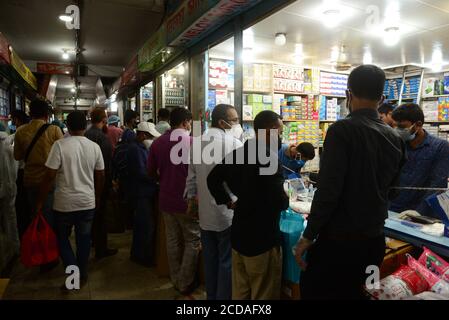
top-left (296, 65), bottom-right (405, 299)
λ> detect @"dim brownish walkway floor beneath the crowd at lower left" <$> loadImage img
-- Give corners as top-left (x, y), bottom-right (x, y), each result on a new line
top-left (3, 231), bottom-right (206, 300)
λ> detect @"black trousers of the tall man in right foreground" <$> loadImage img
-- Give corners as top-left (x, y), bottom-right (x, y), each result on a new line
top-left (300, 235), bottom-right (385, 300)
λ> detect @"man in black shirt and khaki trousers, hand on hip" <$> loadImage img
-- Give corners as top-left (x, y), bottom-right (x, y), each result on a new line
top-left (207, 111), bottom-right (288, 300)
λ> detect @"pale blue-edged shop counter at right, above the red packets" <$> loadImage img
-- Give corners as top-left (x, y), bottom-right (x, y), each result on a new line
top-left (385, 211), bottom-right (449, 257)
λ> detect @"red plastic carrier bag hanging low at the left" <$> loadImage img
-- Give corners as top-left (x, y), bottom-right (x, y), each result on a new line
top-left (20, 212), bottom-right (59, 267)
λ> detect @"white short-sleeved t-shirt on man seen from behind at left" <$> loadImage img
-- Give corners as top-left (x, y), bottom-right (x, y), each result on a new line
top-left (45, 136), bottom-right (104, 212)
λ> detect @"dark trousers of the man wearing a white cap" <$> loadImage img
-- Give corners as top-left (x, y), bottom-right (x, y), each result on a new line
top-left (131, 197), bottom-right (155, 263)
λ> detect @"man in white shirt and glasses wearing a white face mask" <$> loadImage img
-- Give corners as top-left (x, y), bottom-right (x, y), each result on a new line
top-left (185, 104), bottom-right (243, 300)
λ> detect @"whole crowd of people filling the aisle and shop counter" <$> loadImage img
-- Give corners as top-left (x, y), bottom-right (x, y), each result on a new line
top-left (0, 65), bottom-right (449, 300)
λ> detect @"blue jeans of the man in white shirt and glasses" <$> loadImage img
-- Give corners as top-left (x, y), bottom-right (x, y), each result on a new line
top-left (201, 228), bottom-right (232, 300)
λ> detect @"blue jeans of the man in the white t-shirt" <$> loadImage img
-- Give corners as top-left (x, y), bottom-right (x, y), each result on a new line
top-left (55, 209), bottom-right (95, 278)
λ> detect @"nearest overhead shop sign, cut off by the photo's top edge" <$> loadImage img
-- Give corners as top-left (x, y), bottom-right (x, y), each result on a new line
top-left (165, 0), bottom-right (261, 46)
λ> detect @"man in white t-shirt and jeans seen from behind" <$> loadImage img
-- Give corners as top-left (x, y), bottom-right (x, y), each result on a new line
top-left (37, 111), bottom-right (104, 286)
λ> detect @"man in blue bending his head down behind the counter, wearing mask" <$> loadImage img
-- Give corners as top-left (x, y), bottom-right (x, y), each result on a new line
top-left (279, 142), bottom-right (315, 179)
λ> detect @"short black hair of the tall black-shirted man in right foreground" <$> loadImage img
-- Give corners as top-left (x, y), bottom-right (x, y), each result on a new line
top-left (348, 64), bottom-right (385, 101)
